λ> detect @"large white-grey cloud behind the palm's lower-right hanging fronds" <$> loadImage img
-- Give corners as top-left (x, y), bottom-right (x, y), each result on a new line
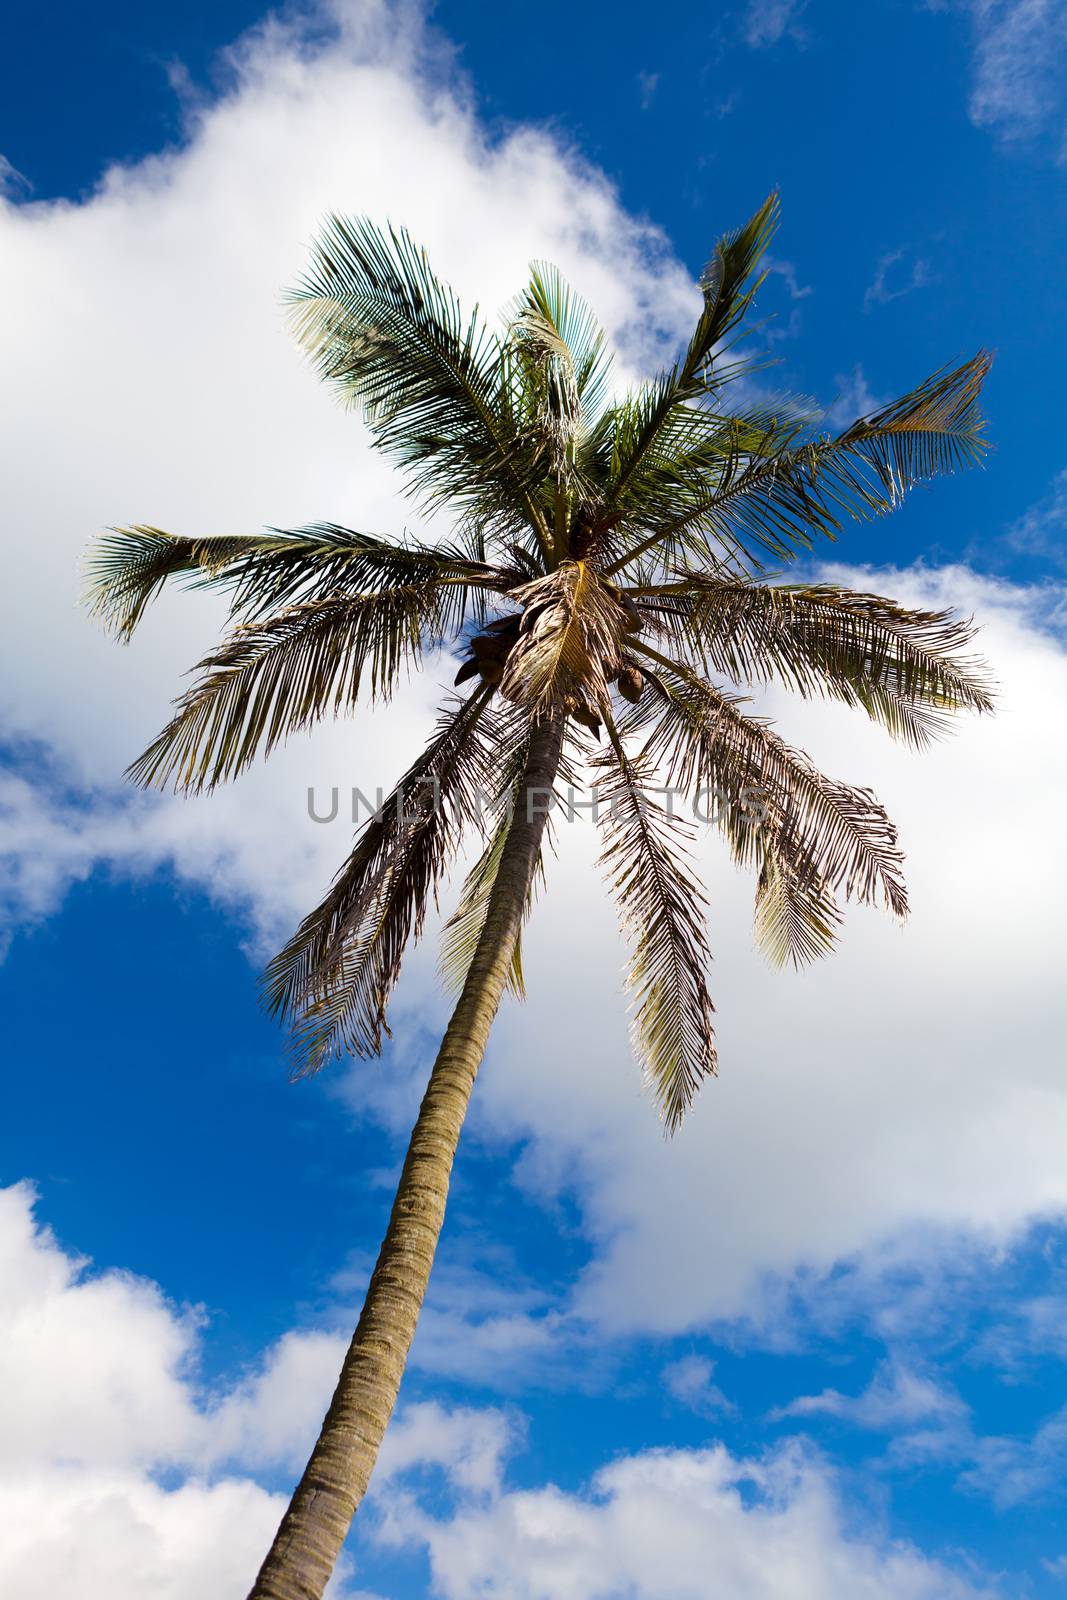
top-left (475, 570), bottom-right (1067, 1333)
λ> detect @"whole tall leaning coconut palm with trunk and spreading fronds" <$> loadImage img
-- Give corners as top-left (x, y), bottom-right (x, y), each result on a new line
top-left (93, 197), bottom-right (990, 1600)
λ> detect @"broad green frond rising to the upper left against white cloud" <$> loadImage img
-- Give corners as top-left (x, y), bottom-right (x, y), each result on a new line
top-left (291, 216), bottom-right (549, 550)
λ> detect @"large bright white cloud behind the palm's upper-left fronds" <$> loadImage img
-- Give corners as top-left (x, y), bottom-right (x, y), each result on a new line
top-left (0, 0), bottom-right (697, 931)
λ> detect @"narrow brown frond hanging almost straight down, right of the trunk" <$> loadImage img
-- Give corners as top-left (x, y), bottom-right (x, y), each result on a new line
top-left (597, 722), bottom-right (715, 1133)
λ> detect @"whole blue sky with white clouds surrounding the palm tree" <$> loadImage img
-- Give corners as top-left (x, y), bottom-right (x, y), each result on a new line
top-left (0, 0), bottom-right (1067, 1600)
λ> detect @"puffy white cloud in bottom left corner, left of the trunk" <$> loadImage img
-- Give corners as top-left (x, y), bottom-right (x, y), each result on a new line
top-left (0, 1184), bottom-right (355, 1600)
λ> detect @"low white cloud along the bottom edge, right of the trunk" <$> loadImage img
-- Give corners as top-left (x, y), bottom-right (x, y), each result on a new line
top-left (381, 1443), bottom-right (992, 1600)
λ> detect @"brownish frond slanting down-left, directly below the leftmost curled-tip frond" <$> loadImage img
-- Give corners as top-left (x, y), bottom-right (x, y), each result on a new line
top-left (128, 582), bottom-right (442, 794)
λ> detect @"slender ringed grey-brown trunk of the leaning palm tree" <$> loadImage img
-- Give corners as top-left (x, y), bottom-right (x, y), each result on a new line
top-left (248, 714), bottom-right (563, 1600)
